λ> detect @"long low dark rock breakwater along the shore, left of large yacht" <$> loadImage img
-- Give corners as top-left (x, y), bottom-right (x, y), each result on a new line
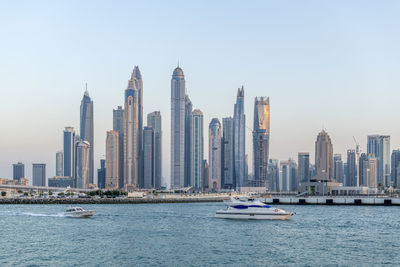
top-left (0, 196), bottom-right (229, 205)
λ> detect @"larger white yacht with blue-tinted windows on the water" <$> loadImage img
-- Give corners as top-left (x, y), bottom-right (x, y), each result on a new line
top-left (215, 198), bottom-right (295, 220)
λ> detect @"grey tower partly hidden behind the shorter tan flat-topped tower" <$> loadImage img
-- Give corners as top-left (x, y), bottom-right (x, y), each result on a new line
top-left (113, 106), bottom-right (124, 188)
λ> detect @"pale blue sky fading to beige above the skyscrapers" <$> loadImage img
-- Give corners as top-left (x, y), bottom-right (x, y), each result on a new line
top-left (0, 0), bottom-right (400, 186)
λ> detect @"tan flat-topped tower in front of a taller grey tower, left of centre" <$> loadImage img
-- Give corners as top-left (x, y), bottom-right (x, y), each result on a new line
top-left (105, 131), bottom-right (120, 189)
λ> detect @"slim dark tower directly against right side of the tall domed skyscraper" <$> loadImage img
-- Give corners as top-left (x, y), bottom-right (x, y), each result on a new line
top-left (185, 95), bottom-right (193, 186)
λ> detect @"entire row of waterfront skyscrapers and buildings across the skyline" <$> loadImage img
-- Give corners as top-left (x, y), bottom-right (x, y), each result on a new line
top-left (8, 66), bottom-right (400, 194)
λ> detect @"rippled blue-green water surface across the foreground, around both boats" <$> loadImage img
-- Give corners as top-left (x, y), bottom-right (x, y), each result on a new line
top-left (0, 203), bottom-right (400, 266)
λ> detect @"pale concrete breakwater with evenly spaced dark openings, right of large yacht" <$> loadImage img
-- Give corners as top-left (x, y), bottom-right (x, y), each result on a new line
top-left (260, 197), bottom-right (400, 206)
